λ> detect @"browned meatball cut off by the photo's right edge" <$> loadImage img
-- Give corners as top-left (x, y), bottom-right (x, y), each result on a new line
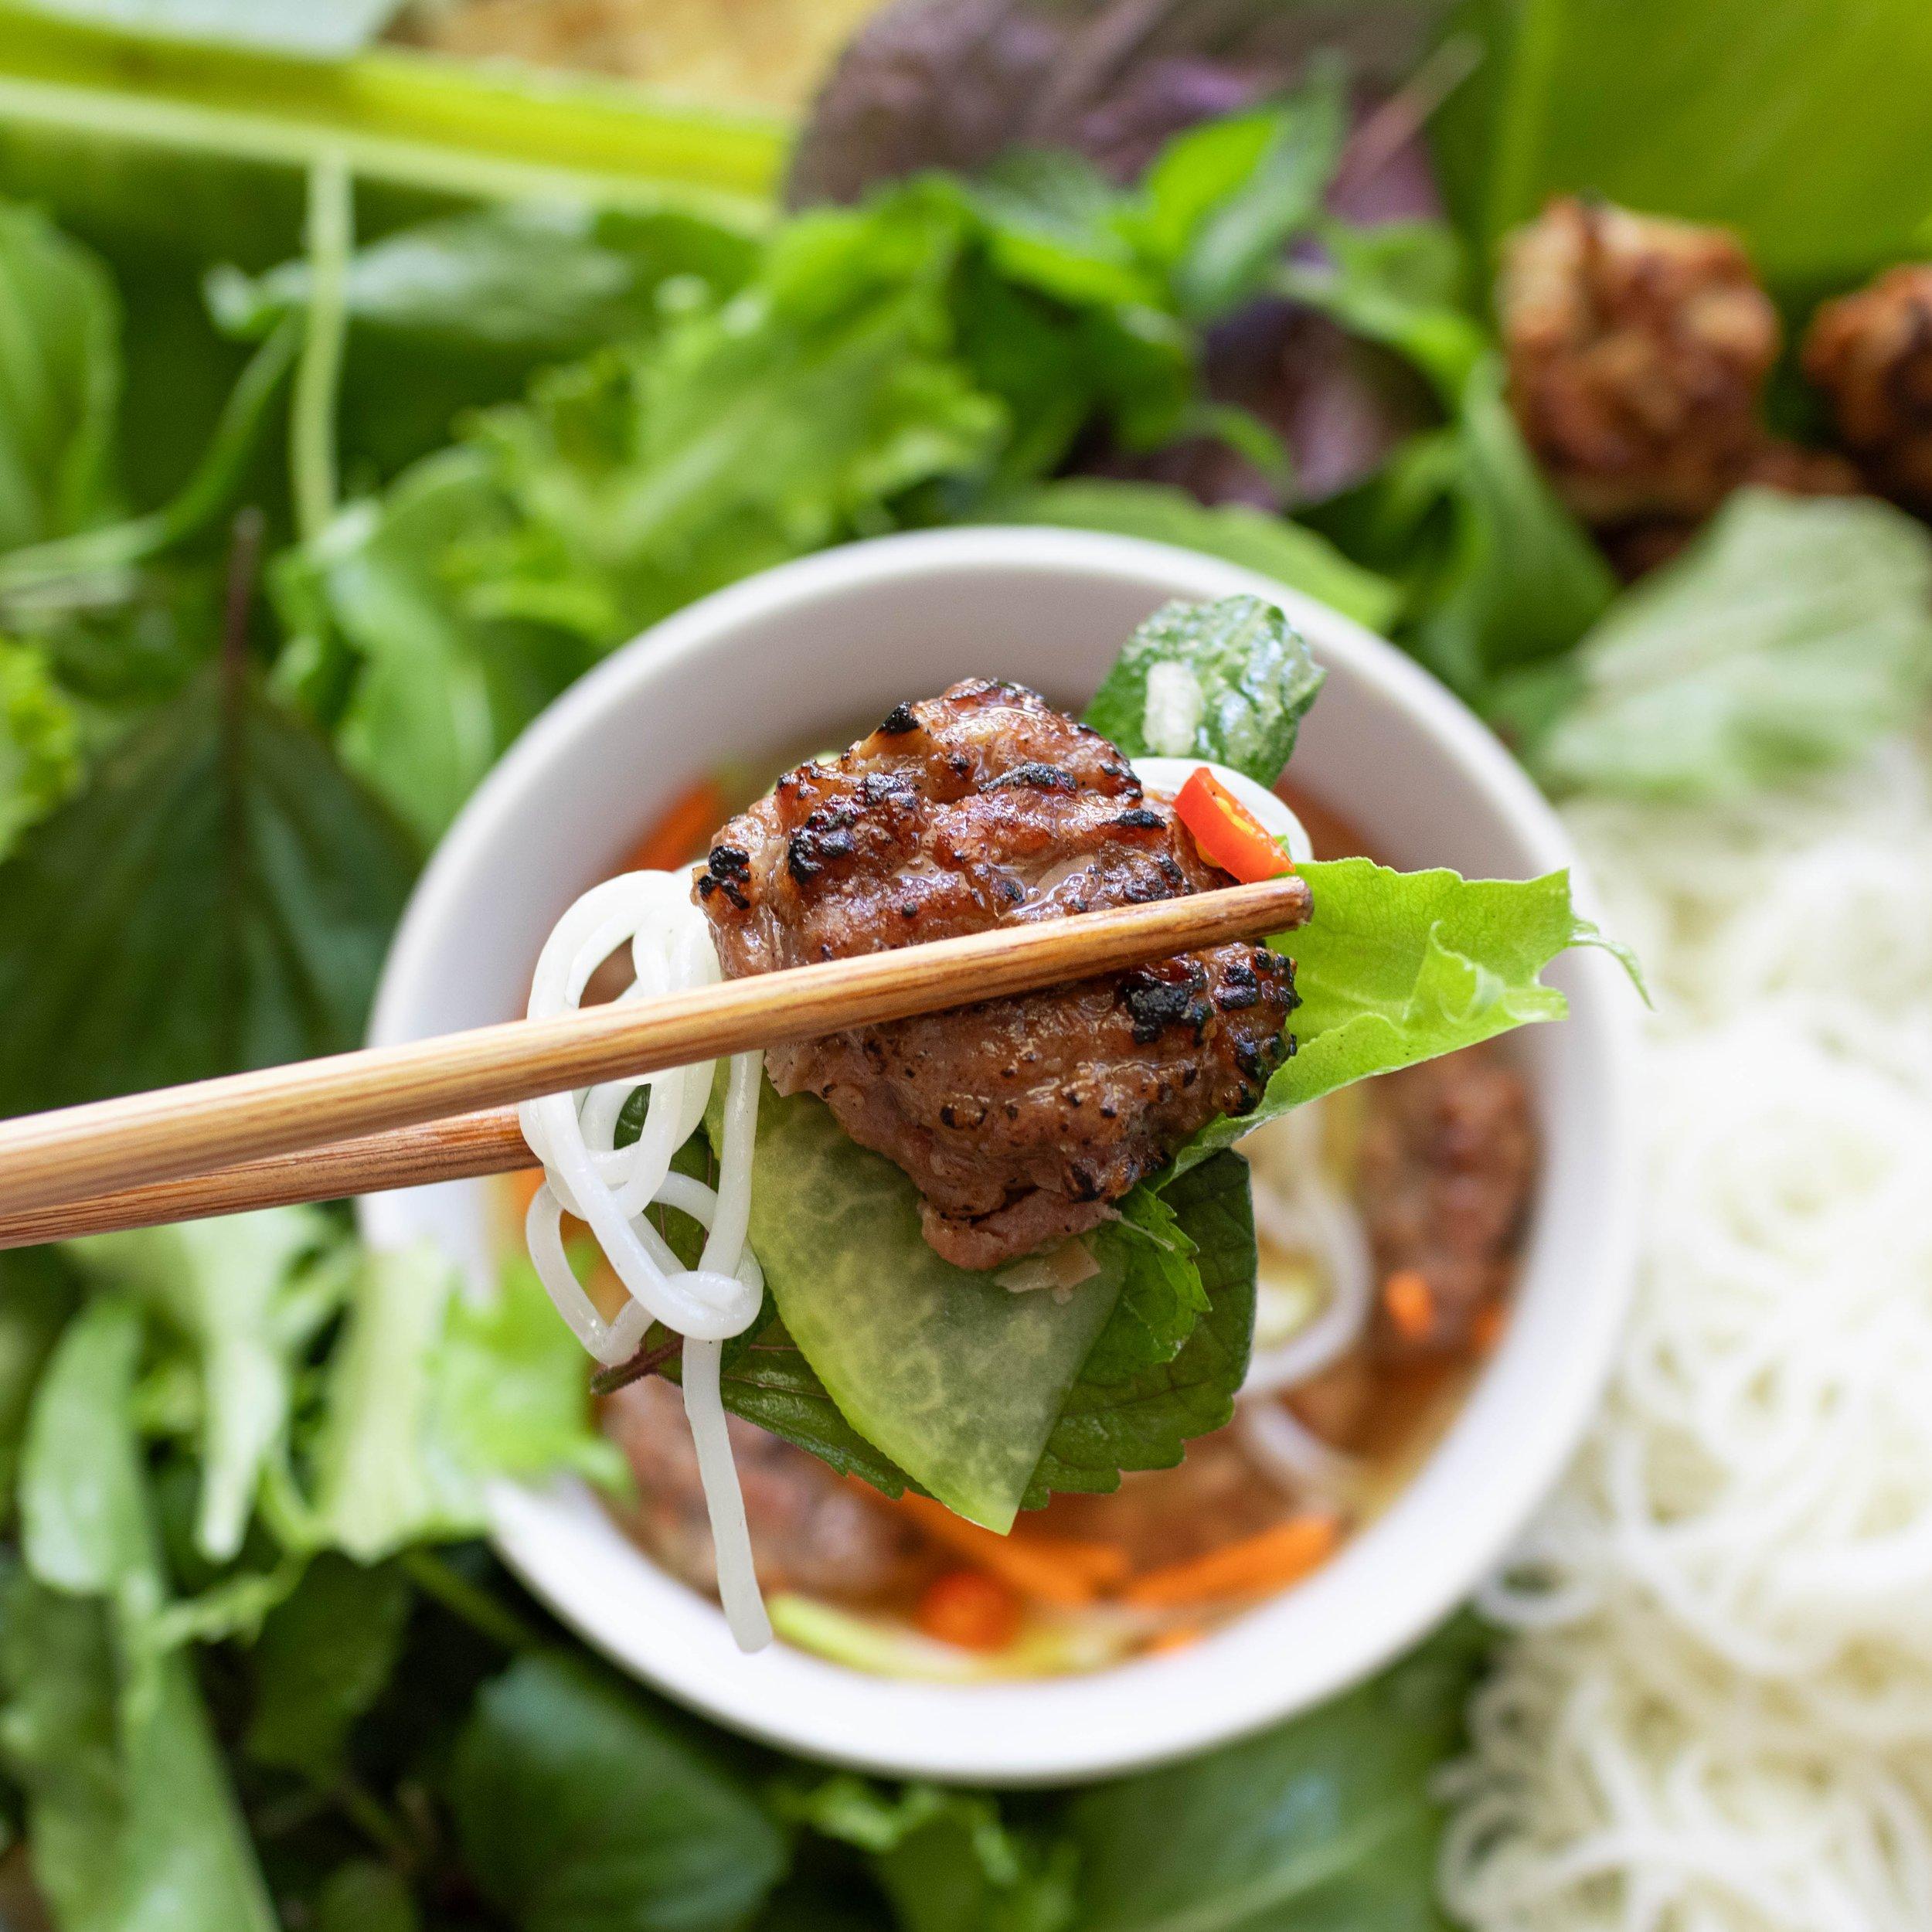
top-left (1804, 263), bottom-right (1932, 510)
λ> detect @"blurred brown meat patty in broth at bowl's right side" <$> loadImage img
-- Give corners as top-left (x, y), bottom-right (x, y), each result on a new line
top-left (1359, 1047), bottom-right (1536, 1359)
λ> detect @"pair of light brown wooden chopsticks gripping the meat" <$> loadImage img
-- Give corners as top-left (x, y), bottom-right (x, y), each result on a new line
top-left (0, 873), bottom-right (1308, 1248)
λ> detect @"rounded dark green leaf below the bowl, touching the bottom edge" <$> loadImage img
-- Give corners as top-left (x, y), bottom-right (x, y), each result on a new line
top-left (451, 1656), bottom-right (787, 1932)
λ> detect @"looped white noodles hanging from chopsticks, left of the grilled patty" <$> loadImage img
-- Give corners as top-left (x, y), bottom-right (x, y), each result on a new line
top-left (520, 872), bottom-right (771, 1650)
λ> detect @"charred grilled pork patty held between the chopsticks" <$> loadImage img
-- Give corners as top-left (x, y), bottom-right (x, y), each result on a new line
top-left (696, 679), bottom-right (1306, 1267)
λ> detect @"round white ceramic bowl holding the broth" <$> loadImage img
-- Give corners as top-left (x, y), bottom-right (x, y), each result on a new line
top-left (362, 528), bottom-right (1634, 1784)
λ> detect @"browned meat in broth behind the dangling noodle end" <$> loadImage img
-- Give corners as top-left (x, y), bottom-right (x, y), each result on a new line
top-left (605, 1376), bottom-right (934, 1604)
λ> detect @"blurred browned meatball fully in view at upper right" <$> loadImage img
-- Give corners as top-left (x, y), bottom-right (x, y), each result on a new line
top-left (1498, 199), bottom-right (1780, 526)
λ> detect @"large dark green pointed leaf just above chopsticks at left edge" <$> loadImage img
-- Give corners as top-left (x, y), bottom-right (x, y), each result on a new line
top-left (0, 675), bottom-right (413, 1113)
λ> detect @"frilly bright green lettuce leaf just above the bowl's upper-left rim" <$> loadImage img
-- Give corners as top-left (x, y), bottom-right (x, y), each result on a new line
top-left (456, 196), bottom-right (1005, 645)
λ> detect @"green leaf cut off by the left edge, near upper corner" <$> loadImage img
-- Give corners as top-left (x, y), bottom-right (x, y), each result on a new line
top-left (0, 203), bottom-right (122, 551)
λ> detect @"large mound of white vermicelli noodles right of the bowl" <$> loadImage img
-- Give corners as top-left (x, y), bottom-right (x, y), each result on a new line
top-left (1444, 744), bottom-right (1932, 1932)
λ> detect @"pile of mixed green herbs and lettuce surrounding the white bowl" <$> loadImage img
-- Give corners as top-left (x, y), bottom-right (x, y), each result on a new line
top-left (0, 0), bottom-right (1932, 1932)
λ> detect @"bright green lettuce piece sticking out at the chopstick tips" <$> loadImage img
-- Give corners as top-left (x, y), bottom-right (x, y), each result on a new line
top-left (1177, 858), bottom-right (1602, 1171)
